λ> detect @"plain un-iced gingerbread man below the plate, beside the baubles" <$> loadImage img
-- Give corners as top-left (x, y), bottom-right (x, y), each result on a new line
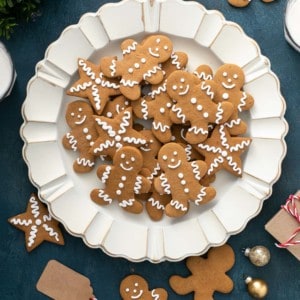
top-left (169, 244), bottom-right (235, 300)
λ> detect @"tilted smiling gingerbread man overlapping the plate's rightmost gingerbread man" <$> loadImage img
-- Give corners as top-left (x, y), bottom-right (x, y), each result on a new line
top-left (167, 71), bottom-right (233, 144)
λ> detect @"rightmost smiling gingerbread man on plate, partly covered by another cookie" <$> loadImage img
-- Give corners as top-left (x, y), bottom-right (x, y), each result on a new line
top-left (214, 64), bottom-right (254, 135)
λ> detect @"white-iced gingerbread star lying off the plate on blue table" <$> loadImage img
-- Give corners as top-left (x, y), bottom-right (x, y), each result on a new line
top-left (8, 194), bottom-right (64, 252)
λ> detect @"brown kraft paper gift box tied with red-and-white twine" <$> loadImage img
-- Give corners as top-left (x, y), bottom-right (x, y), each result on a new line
top-left (265, 190), bottom-right (300, 260)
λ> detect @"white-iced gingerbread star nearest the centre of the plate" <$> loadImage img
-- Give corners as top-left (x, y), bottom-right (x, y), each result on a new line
top-left (90, 107), bottom-right (147, 157)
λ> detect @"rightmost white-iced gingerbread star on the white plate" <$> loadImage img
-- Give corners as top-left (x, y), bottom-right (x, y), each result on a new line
top-left (195, 125), bottom-right (251, 176)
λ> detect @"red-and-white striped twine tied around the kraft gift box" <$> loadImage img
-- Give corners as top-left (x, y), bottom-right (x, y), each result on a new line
top-left (275, 195), bottom-right (300, 248)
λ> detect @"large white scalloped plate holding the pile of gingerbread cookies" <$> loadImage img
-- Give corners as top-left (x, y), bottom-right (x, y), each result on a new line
top-left (21, 0), bottom-right (288, 262)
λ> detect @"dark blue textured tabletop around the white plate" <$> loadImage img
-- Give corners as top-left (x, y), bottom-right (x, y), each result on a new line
top-left (0, 0), bottom-right (300, 300)
